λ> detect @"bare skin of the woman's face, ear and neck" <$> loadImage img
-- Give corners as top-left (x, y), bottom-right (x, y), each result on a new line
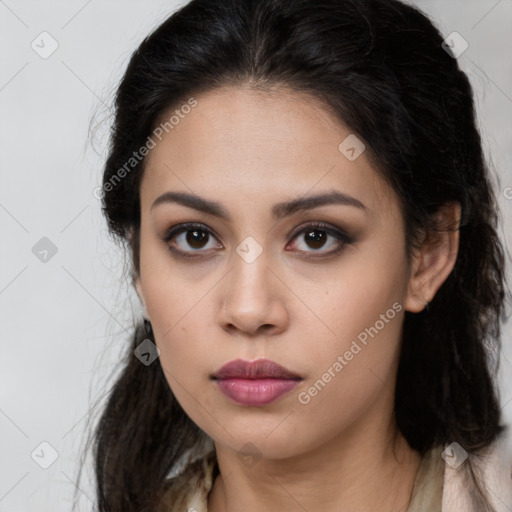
top-left (136, 86), bottom-right (460, 512)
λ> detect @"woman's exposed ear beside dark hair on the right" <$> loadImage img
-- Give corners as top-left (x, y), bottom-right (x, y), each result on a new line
top-left (405, 202), bottom-right (460, 313)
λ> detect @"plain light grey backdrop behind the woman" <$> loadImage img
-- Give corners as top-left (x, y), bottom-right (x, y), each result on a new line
top-left (0, 0), bottom-right (512, 512)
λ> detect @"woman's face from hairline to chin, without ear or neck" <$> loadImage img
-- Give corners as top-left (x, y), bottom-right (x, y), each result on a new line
top-left (137, 87), bottom-right (422, 459)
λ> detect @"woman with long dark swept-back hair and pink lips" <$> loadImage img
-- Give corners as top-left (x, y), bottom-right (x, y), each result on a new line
top-left (84, 0), bottom-right (512, 512)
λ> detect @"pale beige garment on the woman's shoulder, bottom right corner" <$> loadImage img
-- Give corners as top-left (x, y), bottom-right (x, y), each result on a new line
top-left (442, 436), bottom-right (512, 512)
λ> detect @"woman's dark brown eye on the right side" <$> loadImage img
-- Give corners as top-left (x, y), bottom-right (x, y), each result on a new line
top-left (286, 222), bottom-right (352, 256)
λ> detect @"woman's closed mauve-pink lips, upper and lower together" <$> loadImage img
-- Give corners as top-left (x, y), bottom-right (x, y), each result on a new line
top-left (212, 359), bottom-right (302, 405)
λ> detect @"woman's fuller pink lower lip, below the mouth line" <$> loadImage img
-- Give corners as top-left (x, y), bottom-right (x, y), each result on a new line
top-left (216, 379), bottom-right (299, 405)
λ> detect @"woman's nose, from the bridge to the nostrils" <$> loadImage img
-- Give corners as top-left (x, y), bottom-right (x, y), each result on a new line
top-left (219, 253), bottom-right (289, 336)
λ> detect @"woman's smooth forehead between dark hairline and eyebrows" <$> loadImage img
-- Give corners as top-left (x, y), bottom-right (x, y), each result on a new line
top-left (141, 87), bottom-right (394, 220)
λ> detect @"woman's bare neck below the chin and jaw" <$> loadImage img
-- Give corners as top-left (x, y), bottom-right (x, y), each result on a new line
top-left (208, 416), bottom-right (421, 512)
